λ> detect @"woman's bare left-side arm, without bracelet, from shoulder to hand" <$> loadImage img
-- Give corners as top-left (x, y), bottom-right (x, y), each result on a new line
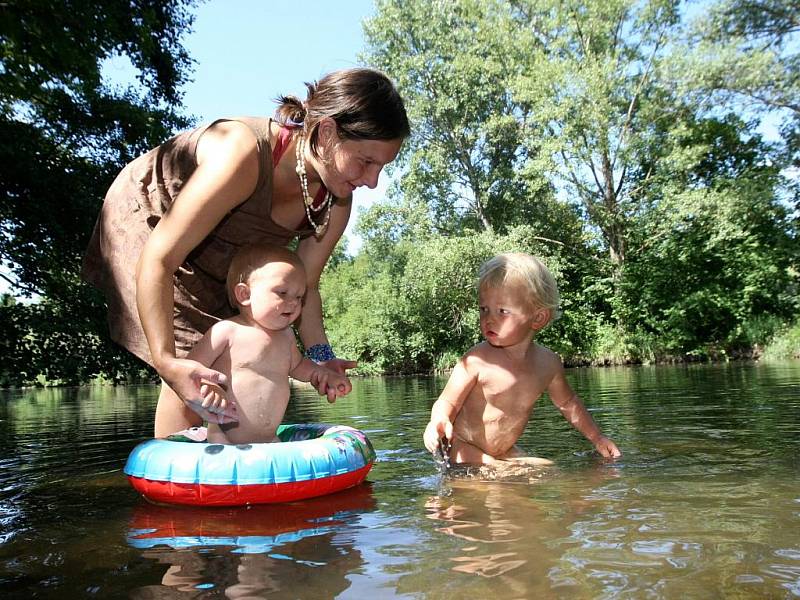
top-left (136, 122), bottom-right (258, 402)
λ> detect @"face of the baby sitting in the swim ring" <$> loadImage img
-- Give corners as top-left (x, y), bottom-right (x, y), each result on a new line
top-left (247, 261), bottom-right (306, 331)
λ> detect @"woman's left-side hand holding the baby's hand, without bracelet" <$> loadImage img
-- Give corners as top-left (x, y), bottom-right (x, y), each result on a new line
top-left (160, 358), bottom-right (239, 425)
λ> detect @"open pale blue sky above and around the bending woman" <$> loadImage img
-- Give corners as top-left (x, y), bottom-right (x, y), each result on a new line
top-left (105, 0), bottom-right (388, 253)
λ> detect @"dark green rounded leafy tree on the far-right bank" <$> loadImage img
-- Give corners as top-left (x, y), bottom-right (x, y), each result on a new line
top-left (619, 113), bottom-right (798, 356)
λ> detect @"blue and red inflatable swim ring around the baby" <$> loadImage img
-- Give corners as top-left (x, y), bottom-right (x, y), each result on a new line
top-left (124, 423), bottom-right (375, 506)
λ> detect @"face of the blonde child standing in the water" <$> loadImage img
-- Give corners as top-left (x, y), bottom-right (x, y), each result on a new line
top-left (478, 287), bottom-right (546, 348)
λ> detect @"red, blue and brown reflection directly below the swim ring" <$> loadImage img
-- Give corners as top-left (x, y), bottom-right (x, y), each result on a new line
top-left (127, 483), bottom-right (375, 598)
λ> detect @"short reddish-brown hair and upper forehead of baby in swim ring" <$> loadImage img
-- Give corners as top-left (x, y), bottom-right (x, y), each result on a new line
top-left (226, 243), bottom-right (306, 311)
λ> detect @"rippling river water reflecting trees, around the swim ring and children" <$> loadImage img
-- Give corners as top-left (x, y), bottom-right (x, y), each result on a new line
top-left (0, 362), bottom-right (800, 600)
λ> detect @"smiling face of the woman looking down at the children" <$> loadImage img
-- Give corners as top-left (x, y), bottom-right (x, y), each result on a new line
top-left (310, 120), bottom-right (403, 198)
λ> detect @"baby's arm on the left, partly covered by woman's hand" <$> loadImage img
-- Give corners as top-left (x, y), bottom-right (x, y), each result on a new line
top-left (187, 321), bottom-right (239, 425)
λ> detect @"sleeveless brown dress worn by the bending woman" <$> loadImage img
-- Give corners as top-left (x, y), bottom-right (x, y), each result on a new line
top-left (83, 117), bottom-right (313, 364)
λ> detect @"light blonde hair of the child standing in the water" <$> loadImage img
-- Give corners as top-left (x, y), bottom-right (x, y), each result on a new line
top-left (478, 252), bottom-right (560, 321)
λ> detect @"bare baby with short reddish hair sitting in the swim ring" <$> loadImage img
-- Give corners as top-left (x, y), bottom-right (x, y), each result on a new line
top-left (187, 244), bottom-right (352, 444)
